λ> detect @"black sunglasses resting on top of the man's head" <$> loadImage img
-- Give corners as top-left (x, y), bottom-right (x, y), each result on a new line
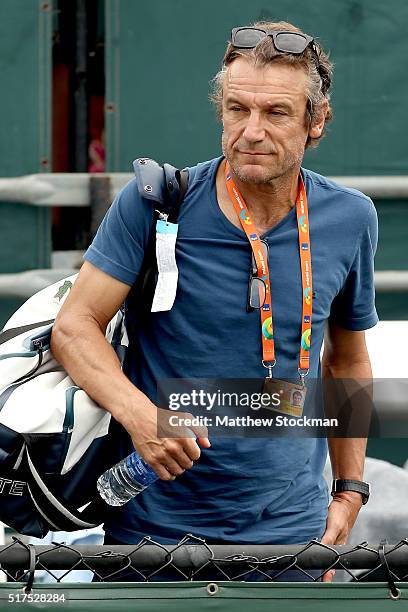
top-left (231, 26), bottom-right (316, 55)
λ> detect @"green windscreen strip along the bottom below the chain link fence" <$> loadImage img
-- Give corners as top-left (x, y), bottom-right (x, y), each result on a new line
top-left (0, 582), bottom-right (408, 612)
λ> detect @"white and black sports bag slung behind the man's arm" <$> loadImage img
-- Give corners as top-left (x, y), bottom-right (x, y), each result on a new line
top-left (0, 275), bottom-right (128, 536)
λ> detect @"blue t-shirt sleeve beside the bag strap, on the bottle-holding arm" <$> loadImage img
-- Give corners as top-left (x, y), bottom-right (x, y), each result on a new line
top-left (84, 178), bottom-right (153, 285)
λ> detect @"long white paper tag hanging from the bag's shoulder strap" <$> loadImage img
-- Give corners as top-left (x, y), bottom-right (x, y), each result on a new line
top-left (152, 219), bottom-right (178, 312)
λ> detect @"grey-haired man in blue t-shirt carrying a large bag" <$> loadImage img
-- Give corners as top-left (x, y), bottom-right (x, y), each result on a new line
top-left (52, 22), bottom-right (378, 580)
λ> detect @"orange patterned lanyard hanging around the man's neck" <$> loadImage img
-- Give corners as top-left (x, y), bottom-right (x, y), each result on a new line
top-left (225, 161), bottom-right (313, 380)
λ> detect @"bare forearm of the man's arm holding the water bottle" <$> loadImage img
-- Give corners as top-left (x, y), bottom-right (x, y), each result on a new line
top-left (51, 317), bottom-right (151, 426)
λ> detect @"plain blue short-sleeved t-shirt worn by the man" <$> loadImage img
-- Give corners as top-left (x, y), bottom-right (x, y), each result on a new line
top-left (85, 157), bottom-right (378, 544)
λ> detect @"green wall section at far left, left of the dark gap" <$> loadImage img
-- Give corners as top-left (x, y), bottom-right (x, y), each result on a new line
top-left (0, 0), bottom-right (52, 323)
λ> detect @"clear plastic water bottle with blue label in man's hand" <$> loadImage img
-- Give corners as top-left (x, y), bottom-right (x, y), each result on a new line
top-left (97, 452), bottom-right (159, 506)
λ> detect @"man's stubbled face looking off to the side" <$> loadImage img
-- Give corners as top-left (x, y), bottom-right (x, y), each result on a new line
top-left (222, 57), bottom-right (318, 183)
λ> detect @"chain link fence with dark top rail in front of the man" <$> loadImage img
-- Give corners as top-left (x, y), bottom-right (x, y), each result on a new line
top-left (0, 534), bottom-right (408, 599)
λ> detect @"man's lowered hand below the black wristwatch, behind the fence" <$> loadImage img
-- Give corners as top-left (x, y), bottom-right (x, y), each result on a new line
top-left (320, 491), bottom-right (363, 582)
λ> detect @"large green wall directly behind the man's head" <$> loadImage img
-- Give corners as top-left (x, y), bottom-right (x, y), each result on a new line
top-left (106, 0), bottom-right (408, 319)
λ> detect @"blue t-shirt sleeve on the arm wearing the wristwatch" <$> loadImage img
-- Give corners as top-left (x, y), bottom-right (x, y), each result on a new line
top-left (330, 200), bottom-right (378, 331)
